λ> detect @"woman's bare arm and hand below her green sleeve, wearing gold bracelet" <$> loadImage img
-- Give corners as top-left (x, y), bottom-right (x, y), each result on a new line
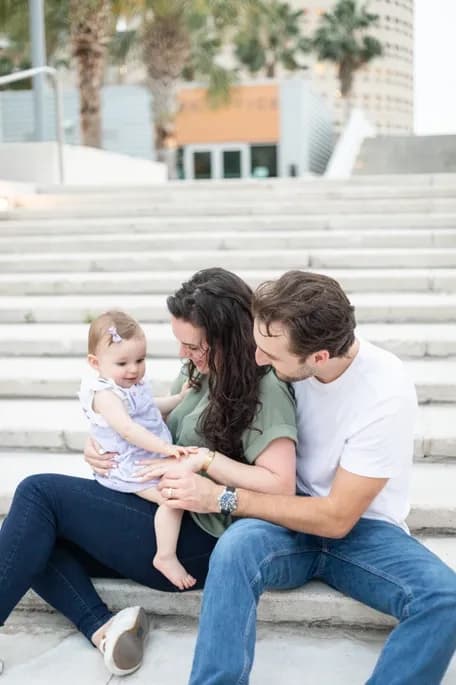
top-left (137, 438), bottom-right (296, 495)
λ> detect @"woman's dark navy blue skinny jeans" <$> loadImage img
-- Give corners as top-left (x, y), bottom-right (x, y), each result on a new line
top-left (0, 474), bottom-right (217, 640)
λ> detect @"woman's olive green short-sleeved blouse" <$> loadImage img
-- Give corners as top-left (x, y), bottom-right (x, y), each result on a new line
top-left (167, 371), bottom-right (297, 537)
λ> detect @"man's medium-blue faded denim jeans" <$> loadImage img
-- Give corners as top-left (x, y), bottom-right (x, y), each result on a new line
top-left (190, 519), bottom-right (456, 685)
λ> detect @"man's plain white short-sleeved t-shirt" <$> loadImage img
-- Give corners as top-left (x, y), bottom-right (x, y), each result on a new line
top-left (293, 340), bottom-right (417, 530)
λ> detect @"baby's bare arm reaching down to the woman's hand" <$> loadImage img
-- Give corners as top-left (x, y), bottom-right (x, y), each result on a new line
top-left (93, 390), bottom-right (189, 457)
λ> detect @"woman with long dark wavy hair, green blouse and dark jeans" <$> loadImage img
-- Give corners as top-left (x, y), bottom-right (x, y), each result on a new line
top-left (0, 268), bottom-right (296, 675)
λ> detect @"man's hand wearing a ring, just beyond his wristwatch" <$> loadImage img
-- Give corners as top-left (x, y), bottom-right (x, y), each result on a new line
top-left (157, 472), bottom-right (224, 514)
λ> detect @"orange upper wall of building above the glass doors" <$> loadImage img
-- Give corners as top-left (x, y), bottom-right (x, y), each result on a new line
top-left (176, 83), bottom-right (279, 145)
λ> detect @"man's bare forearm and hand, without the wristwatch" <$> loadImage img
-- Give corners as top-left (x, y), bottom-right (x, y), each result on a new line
top-left (158, 467), bottom-right (388, 538)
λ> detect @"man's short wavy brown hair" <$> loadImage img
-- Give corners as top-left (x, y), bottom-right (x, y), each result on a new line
top-left (252, 271), bottom-right (356, 359)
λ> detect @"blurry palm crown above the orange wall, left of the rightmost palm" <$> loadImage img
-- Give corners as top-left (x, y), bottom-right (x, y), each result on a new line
top-left (234, 0), bottom-right (310, 78)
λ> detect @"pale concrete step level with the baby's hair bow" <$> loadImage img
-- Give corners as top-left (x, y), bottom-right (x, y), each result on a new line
top-left (0, 320), bottom-right (456, 358)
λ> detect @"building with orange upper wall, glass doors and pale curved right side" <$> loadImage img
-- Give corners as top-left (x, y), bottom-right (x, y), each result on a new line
top-left (175, 77), bottom-right (334, 179)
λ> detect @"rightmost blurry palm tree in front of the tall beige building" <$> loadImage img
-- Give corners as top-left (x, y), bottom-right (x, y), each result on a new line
top-left (311, 0), bottom-right (383, 116)
